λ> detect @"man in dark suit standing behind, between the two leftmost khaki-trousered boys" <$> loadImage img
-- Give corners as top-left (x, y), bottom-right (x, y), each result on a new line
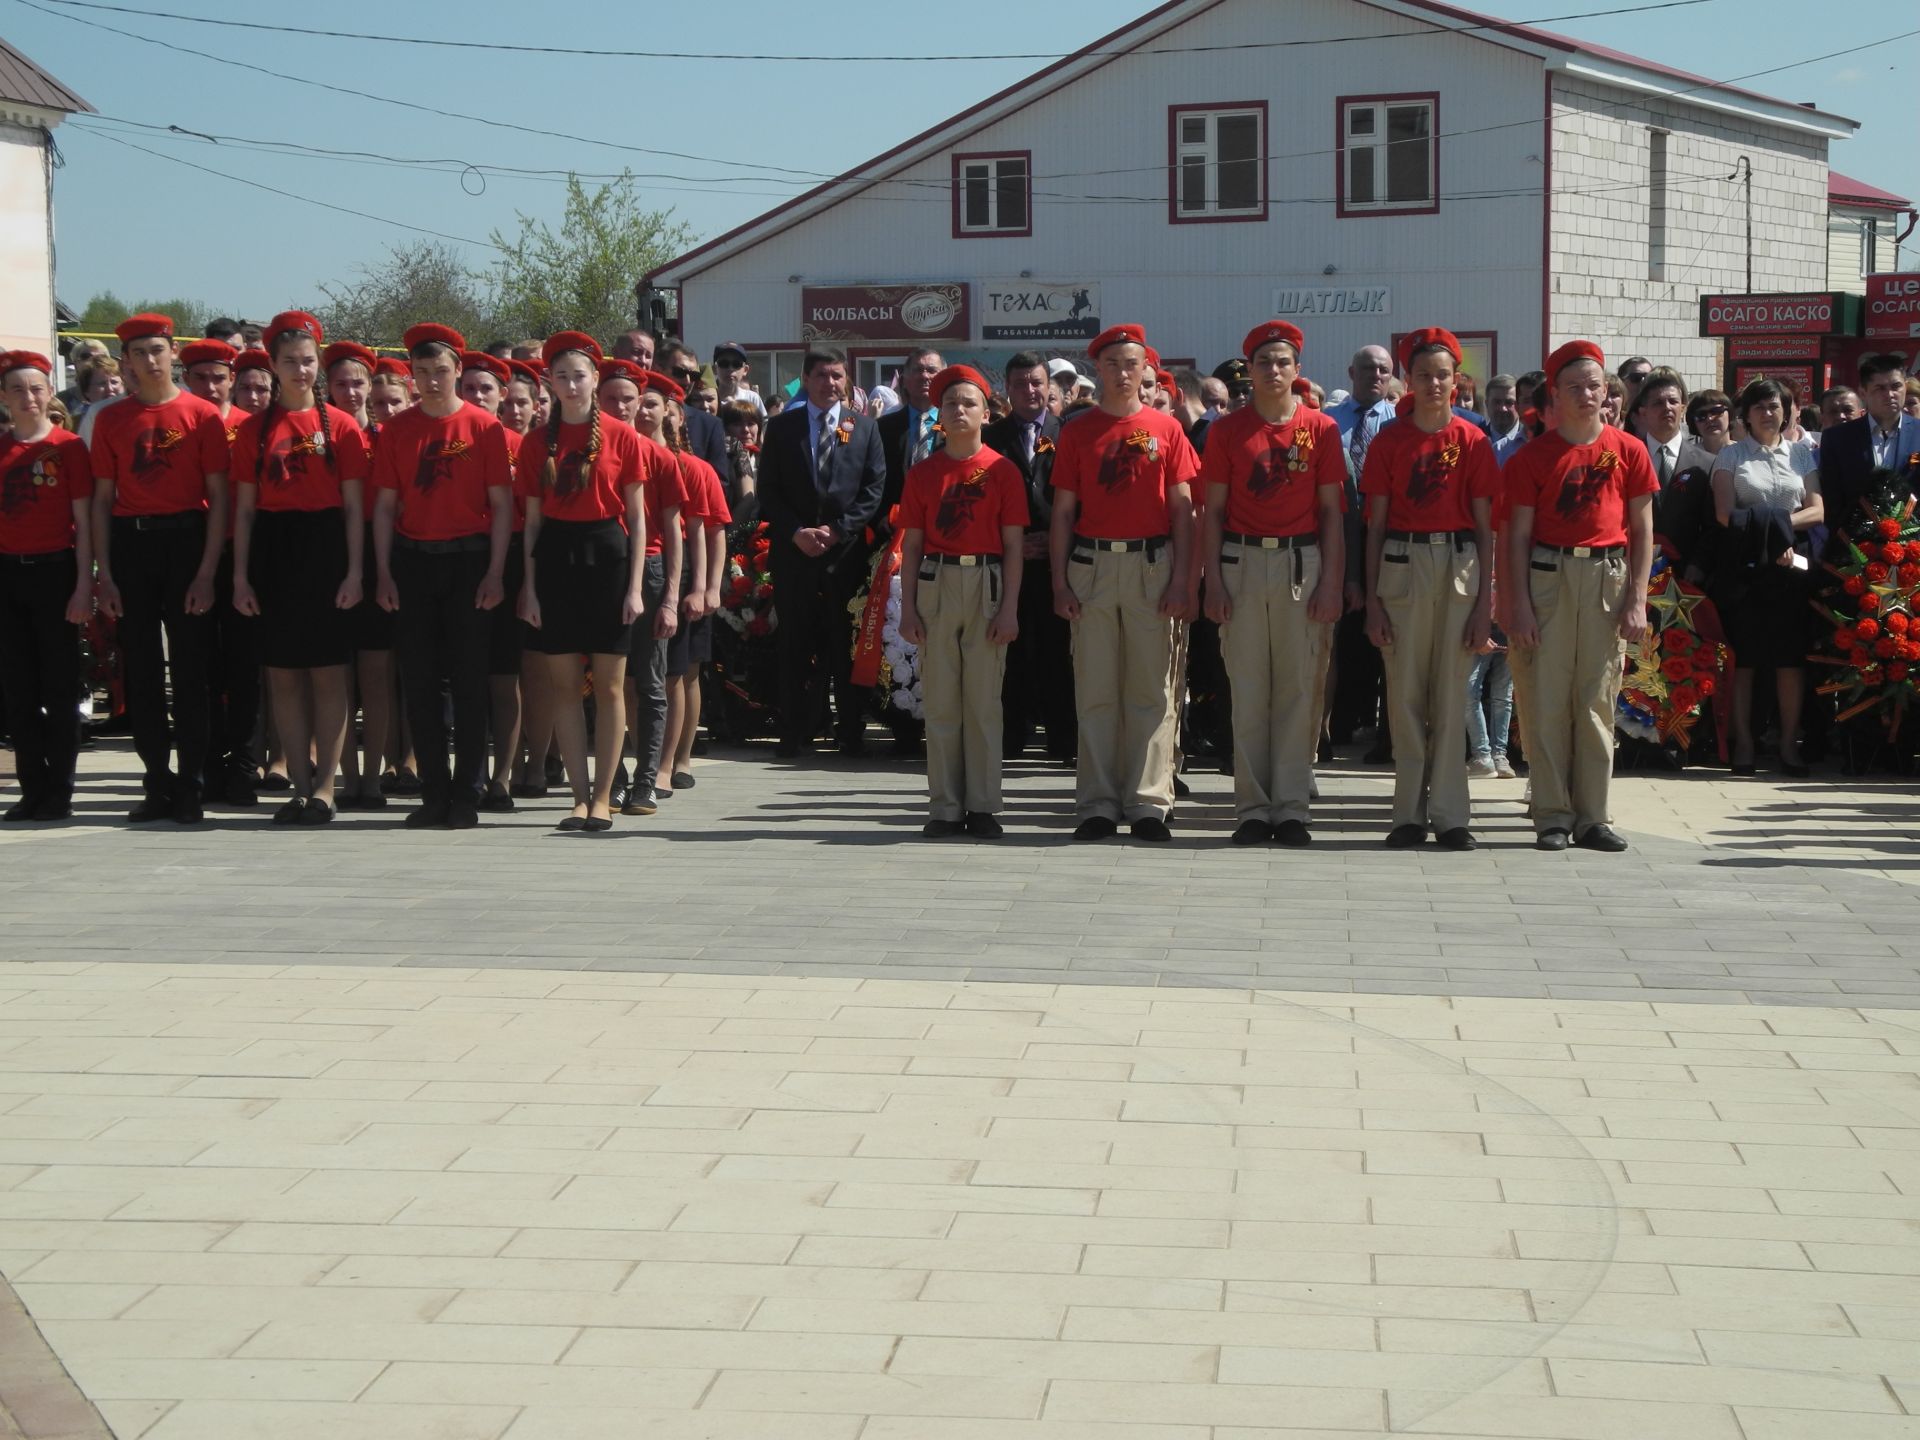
top-left (981, 351), bottom-right (1079, 764)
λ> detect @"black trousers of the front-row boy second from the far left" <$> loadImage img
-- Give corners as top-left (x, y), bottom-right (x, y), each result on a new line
top-left (111, 516), bottom-right (211, 795)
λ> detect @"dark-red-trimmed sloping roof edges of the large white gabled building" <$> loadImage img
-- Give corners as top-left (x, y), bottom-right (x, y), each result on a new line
top-left (636, 0), bottom-right (1860, 290)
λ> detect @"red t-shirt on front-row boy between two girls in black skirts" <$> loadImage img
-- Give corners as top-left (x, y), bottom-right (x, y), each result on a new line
top-left (372, 405), bottom-right (513, 540)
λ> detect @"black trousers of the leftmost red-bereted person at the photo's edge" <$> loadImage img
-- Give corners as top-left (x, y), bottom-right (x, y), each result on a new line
top-left (0, 549), bottom-right (81, 801)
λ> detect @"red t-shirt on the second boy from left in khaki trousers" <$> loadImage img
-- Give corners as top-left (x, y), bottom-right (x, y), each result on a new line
top-left (1052, 409), bottom-right (1200, 540)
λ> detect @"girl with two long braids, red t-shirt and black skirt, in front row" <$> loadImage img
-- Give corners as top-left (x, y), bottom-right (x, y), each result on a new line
top-left (516, 330), bottom-right (645, 833)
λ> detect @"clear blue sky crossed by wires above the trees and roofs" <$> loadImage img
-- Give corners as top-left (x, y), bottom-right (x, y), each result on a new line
top-left (0, 0), bottom-right (1920, 319)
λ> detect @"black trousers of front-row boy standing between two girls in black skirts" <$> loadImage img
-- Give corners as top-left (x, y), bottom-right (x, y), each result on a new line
top-left (394, 538), bottom-right (505, 804)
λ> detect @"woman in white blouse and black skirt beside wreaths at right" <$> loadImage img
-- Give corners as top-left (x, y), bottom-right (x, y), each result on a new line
top-left (1713, 376), bottom-right (1826, 778)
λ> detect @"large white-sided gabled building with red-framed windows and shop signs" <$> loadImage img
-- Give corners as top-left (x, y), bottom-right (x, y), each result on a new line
top-left (643, 0), bottom-right (1859, 395)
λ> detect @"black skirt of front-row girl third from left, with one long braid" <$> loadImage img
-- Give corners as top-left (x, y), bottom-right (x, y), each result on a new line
top-left (248, 509), bottom-right (353, 670)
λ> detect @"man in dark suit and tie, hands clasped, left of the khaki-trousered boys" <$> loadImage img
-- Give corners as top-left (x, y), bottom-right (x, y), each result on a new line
top-left (758, 348), bottom-right (887, 758)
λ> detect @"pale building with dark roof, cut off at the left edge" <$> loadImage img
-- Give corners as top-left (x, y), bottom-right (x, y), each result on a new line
top-left (0, 40), bottom-right (92, 355)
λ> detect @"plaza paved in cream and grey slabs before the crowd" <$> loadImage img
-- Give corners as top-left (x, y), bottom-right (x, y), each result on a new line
top-left (0, 745), bottom-right (1920, 1440)
